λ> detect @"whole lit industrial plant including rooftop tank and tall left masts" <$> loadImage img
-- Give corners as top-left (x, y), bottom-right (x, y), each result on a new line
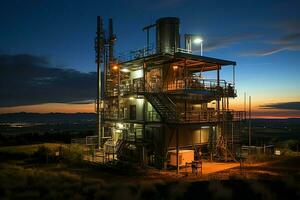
top-left (72, 17), bottom-right (246, 171)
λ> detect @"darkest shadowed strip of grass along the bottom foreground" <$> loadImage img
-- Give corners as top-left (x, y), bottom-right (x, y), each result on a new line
top-left (0, 164), bottom-right (300, 200)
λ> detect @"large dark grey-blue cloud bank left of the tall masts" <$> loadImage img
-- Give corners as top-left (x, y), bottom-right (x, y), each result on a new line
top-left (0, 54), bottom-right (96, 107)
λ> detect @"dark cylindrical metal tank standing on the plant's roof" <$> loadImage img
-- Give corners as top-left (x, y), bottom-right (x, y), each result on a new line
top-left (156, 17), bottom-right (180, 53)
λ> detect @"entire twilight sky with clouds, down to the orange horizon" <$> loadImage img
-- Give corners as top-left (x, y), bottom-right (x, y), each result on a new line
top-left (0, 0), bottom-right (300, 117)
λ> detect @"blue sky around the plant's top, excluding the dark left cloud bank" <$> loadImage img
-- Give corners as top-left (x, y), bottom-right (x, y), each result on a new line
top-left (0, 0), bottom-right (300, 117)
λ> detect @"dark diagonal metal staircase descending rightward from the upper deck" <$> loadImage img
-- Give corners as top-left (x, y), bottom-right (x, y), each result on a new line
top-left (144, 92), bottom-right (180, 123)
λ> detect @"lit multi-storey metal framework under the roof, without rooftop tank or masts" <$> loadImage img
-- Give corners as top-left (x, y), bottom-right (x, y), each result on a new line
top-left (104, 47), bottom-right (245, 167)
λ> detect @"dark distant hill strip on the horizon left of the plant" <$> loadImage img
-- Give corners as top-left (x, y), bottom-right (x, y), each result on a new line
top-left (0, 112), bottom-right (96, 123)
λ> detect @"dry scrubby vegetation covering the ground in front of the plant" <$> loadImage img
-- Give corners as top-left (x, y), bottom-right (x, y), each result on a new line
top-left (0, 144), bottom-right (300, 200)
